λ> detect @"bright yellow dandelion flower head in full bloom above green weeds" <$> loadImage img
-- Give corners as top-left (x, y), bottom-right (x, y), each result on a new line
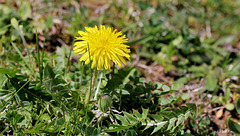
top-left (73, 25), bottom-right (130, 70)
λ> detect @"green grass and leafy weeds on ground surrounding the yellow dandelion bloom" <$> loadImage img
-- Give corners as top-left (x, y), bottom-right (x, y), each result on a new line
top-left (0, 0), bottom-right (240, 136)
